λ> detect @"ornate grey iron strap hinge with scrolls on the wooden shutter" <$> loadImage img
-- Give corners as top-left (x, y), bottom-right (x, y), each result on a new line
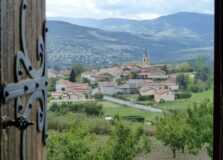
top-left (3, 0), bottom-right (47, 160)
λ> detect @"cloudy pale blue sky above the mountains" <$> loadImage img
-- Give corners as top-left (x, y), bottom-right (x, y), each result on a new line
top-left (47, 0), bottom-right (214, 19)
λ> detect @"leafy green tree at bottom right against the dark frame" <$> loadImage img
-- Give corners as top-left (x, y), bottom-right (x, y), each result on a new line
top-left (187, 102), bottom-right (213, 157)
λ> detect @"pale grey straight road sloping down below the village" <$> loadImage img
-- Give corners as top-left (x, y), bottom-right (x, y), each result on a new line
top-left (103, 96), bottom-right (163, 113)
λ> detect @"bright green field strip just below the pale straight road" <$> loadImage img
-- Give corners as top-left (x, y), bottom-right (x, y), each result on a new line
top-left (100, 101), bottom-right (161, 121)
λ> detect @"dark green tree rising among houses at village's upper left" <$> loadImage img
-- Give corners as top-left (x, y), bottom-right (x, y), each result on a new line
top-left (69, 64), bottom-right (86, 82)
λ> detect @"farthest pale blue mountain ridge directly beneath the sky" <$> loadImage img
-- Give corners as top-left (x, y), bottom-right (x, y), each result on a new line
top-left (49, 12), bottom-right (214, 36)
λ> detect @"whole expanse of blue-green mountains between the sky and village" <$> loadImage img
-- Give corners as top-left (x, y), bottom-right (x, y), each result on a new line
top-left (48, 13), bottom-right (214, 67)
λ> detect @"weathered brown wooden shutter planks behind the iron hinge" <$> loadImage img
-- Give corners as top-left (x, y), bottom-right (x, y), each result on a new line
top-left (0, 0), bottom-right (46, 160)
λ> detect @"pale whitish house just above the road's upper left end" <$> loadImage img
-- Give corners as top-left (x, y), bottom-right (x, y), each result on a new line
top-left (98, 82), bottom-right (118, 95)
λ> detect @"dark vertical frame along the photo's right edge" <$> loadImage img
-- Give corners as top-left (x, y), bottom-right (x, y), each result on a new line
top-left (213, 0), bottom-right (223, 160)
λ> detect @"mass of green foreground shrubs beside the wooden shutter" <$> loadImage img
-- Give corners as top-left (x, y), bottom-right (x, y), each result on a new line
top-left (47, 113), bottom-right (151, 160)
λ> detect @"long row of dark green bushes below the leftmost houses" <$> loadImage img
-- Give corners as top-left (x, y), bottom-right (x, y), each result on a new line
top-left (49, 102), bottom-right (103, 116)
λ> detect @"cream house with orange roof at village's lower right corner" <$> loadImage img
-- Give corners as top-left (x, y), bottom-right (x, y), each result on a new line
top-left (154, 89), bottom-right (175, 103)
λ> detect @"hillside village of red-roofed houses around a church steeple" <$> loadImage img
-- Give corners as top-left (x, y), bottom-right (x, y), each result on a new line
top-left (48, 50), bottom-right (179, 103)
